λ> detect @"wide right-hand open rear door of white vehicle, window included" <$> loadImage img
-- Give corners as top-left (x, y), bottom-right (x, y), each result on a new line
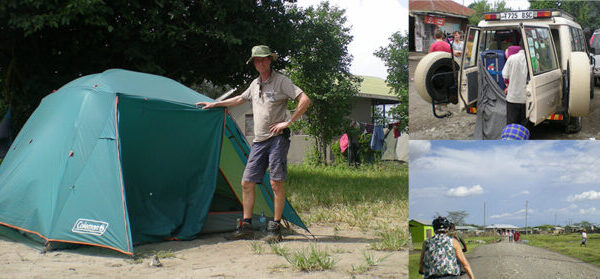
top-left (521, 25), bottom-right (562, 125)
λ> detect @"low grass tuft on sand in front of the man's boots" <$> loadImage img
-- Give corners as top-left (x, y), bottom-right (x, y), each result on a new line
top-left (284, 245), bottom-right (336, 271)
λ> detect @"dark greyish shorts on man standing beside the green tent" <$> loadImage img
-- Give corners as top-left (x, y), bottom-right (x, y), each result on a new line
top-left (242, 134), bottom-right (290, 183)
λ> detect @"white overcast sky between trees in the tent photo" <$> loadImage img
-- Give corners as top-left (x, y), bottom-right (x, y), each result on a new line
top-left (297, 0), bottom-right (408, 79)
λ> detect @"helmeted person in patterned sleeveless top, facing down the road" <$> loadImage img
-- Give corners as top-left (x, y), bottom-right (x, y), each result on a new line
top-left (419, 219), bottom-right (475, 279)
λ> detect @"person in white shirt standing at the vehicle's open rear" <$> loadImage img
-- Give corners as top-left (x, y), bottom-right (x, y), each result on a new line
top-left (502, 40), bottom-right (528, 127)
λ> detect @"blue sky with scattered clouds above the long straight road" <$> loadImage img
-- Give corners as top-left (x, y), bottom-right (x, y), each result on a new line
top-left (409, 140), bottom-right (600, 227)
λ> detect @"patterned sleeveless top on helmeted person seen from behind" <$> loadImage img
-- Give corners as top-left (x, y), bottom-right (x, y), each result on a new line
top-left (423, 233), bottom-right (460, 278)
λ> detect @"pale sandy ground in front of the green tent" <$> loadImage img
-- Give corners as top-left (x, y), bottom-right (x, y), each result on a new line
top-left (0, 226), bottom-right (408, 278)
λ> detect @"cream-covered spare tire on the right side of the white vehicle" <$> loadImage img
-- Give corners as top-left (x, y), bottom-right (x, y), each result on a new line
top-left (567, 52), bottom-right (590, 117)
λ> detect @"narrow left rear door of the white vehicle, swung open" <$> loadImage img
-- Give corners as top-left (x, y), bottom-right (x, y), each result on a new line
top-left (459, 27), bottom-right (481, 113)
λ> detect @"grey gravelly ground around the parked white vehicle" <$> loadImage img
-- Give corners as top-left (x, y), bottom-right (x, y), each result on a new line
top-left (409, 55), bottom-right (600, 140)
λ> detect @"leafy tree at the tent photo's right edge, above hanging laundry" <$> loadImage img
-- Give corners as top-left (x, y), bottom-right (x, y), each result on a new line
top-left (374, 31), bottom-right (408, 130)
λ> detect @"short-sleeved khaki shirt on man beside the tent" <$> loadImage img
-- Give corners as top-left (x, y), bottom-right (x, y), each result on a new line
top-left (242, 71), bottom-right (303, 142)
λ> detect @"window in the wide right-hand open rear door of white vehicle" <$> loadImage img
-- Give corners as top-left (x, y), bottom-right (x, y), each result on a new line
top-left (525, 27), bottom-right (558, 75)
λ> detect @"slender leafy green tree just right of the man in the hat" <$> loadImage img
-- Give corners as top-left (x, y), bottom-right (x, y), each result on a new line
top-left (287, 2), bottom-right (359, 164)
